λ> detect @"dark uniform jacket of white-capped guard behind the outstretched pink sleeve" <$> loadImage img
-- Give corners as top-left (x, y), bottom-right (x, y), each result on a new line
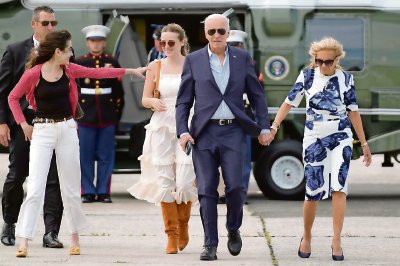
top-left (76, 53), bottom-right (124, 127)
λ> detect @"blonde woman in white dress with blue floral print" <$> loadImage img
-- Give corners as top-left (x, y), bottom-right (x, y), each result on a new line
top-left (271, 37), bottom-right (371, 261)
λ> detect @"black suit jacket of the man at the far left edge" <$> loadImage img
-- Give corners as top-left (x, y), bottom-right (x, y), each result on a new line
top-left (0, 36), bottom-right (33, 125)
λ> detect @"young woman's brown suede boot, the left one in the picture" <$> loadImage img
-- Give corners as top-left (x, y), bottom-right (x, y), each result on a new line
top-left (161, 202), bottom-right (178, 254)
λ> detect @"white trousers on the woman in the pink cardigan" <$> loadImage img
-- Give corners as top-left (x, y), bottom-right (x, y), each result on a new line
top-left (16, 119), bottom-right (88, 240)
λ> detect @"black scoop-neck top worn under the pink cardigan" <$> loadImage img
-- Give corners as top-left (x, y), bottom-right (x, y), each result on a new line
top-left (35, 72), bottom-right (72, 119)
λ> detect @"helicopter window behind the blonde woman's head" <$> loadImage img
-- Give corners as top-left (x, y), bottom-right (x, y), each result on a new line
top-left (306, 17), bottom-right (365, 71)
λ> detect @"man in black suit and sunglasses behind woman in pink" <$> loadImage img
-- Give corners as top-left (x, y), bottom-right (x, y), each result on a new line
top-left (0, 6), bottom-right (63, 248)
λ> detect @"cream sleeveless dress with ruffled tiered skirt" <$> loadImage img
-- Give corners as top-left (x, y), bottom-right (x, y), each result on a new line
top-left (128, 72), bottom-right (198, 205)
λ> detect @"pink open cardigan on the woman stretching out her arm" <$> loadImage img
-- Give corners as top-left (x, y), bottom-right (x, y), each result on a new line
top-left (8, 63), bottom-right (125, 124)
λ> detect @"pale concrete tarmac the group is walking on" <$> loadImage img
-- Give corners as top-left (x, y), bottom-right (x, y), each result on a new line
top-left (0, 155), bottom-right (400, 266)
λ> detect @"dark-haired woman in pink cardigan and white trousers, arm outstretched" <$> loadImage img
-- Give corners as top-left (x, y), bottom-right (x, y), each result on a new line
top-left (8, 30), bottom-right (145, 257)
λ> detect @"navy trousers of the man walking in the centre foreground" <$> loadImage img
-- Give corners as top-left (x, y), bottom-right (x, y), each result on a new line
top-left (193, 123), bottom-right (246, 246)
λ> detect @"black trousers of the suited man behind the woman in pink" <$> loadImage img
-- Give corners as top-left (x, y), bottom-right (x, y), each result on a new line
top-left (1, 111), bottom-right (64, 234)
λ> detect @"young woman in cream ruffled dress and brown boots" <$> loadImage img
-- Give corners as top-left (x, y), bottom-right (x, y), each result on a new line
top-left (128, 24), bottom-right (197, 254)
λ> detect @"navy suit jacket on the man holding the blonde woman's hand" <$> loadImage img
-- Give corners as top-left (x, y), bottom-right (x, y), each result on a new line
top-left (176, 46), bottom-right (269, 139)
